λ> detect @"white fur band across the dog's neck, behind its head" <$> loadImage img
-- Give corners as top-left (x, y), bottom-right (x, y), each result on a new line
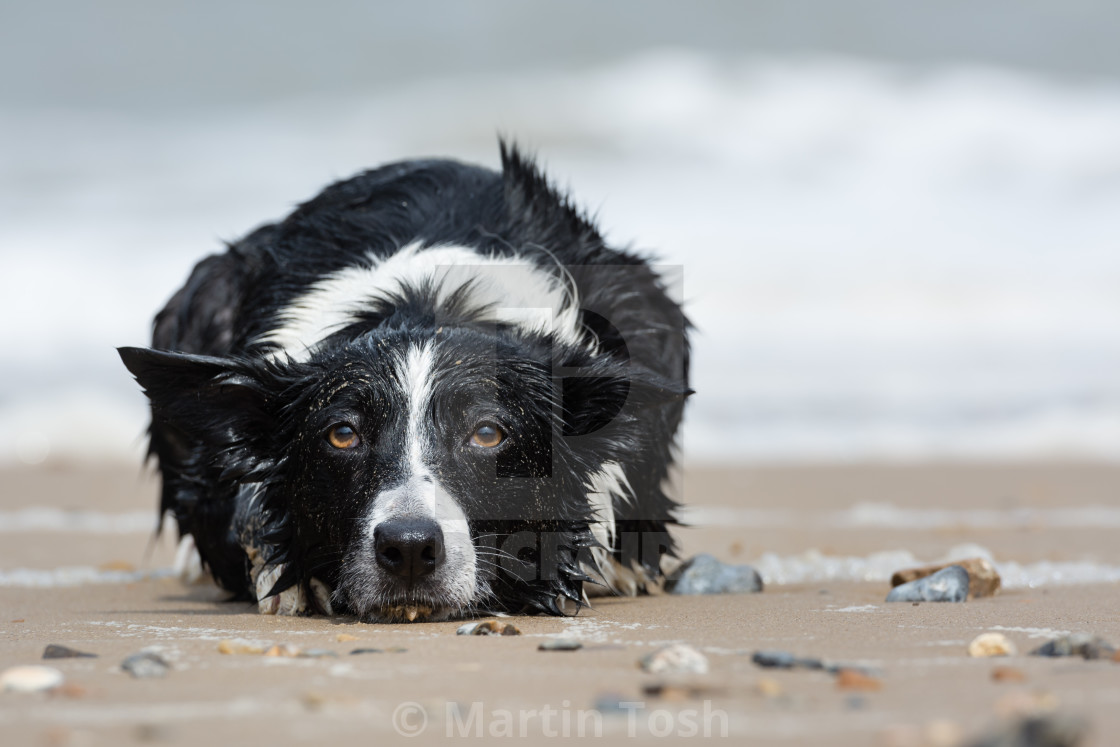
top-left (258, 242), bottom-right (582, 361)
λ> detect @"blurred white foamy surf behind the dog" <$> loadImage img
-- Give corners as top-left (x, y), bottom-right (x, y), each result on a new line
top-left (0, 19), bottom-right (1120, 464)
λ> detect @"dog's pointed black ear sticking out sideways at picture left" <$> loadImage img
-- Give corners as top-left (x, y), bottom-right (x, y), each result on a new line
top-left (118, 347), bottom-right (288, 477)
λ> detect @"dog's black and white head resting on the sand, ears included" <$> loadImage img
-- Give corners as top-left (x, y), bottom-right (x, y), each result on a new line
top-left (121, 325), bottom-right (683, 620)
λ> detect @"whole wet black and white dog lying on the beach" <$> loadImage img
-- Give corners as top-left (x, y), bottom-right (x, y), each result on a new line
top-left (120, 146), bottom-right (689, 622)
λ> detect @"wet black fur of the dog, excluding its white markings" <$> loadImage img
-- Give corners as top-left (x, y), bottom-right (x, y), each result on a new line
top-left (121, 146), bottom-right (688, 614)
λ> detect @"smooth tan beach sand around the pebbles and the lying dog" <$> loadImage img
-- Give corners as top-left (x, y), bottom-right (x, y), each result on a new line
top-left (0, 465), bottom-right (1120, 745)
